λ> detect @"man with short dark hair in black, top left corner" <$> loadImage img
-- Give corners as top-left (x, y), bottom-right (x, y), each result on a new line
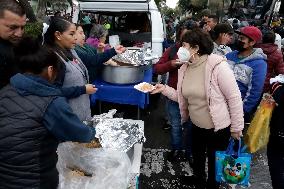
top-left (0, 0), bottom-right (26, 89)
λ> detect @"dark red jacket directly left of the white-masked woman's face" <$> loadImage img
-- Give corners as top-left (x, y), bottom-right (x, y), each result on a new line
top-left (154, 43), bottom-right (180, 89)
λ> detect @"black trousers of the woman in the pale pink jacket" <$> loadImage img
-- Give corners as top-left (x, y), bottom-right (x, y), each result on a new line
top-left (192, 125), bottom-right (231, 189)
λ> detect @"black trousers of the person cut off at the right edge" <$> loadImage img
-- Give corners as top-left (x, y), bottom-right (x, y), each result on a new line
top-left (267, 136), bottom-right (284, 189)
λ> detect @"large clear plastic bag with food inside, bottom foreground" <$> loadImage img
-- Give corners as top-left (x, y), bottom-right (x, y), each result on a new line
top-left (57, 142), bottom-right (131, 189)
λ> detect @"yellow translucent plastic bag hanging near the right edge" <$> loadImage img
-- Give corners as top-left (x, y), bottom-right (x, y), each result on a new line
top-left (245, 93), bottom-right (276, 153)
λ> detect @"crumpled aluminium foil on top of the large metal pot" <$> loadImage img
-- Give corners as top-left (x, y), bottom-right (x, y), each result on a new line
top-left (112, 50), bottom-right (150, 66)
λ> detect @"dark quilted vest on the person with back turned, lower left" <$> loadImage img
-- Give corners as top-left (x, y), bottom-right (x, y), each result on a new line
top-left (0, 85), bottom-right (58, 189)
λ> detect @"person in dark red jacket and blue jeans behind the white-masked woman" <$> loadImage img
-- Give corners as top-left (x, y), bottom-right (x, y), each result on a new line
top-left (153, 21), bottom-right (197, 163)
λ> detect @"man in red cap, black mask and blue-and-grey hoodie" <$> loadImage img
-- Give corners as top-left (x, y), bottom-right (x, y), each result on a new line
top-left (226, 26), bottom-right (267, 123)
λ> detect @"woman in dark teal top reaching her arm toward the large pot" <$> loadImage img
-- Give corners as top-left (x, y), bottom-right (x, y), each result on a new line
top-left (75, 25), bottom-right (122, 82)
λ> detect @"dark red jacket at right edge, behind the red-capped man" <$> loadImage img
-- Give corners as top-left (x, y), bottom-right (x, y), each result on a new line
top-left (258, 43), bottom-right (284, 92)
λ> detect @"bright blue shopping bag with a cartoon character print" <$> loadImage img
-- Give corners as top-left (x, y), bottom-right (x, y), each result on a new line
top-left (215, 138), bottom-right (251, 186)
